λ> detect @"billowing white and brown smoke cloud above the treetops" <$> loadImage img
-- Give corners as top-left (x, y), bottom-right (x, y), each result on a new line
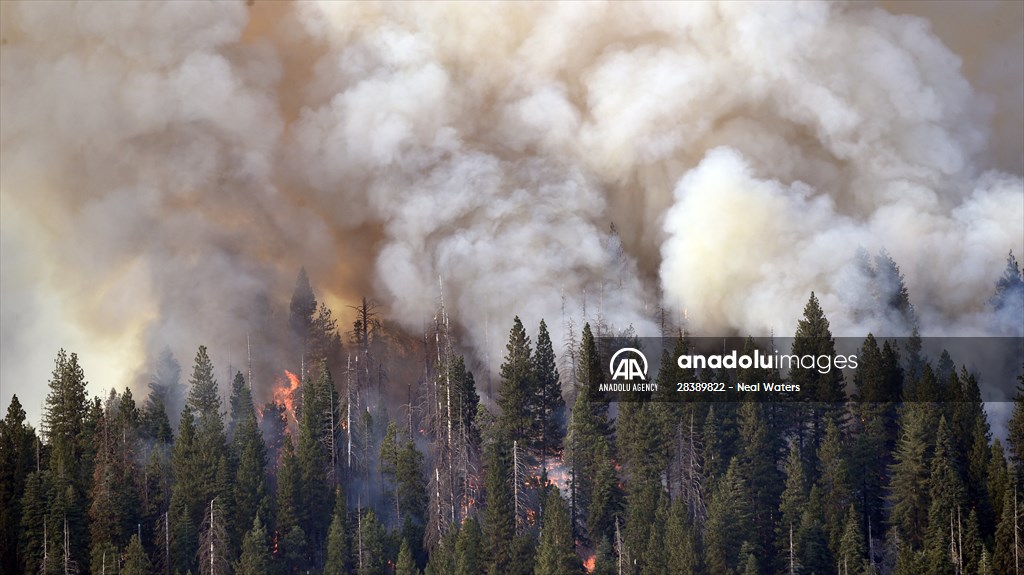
top-left (0, 2), bottom-right (1024, 421)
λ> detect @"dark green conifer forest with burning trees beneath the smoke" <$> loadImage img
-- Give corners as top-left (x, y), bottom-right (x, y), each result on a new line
top-left (0, 254), bottom-right (1024, 575)
